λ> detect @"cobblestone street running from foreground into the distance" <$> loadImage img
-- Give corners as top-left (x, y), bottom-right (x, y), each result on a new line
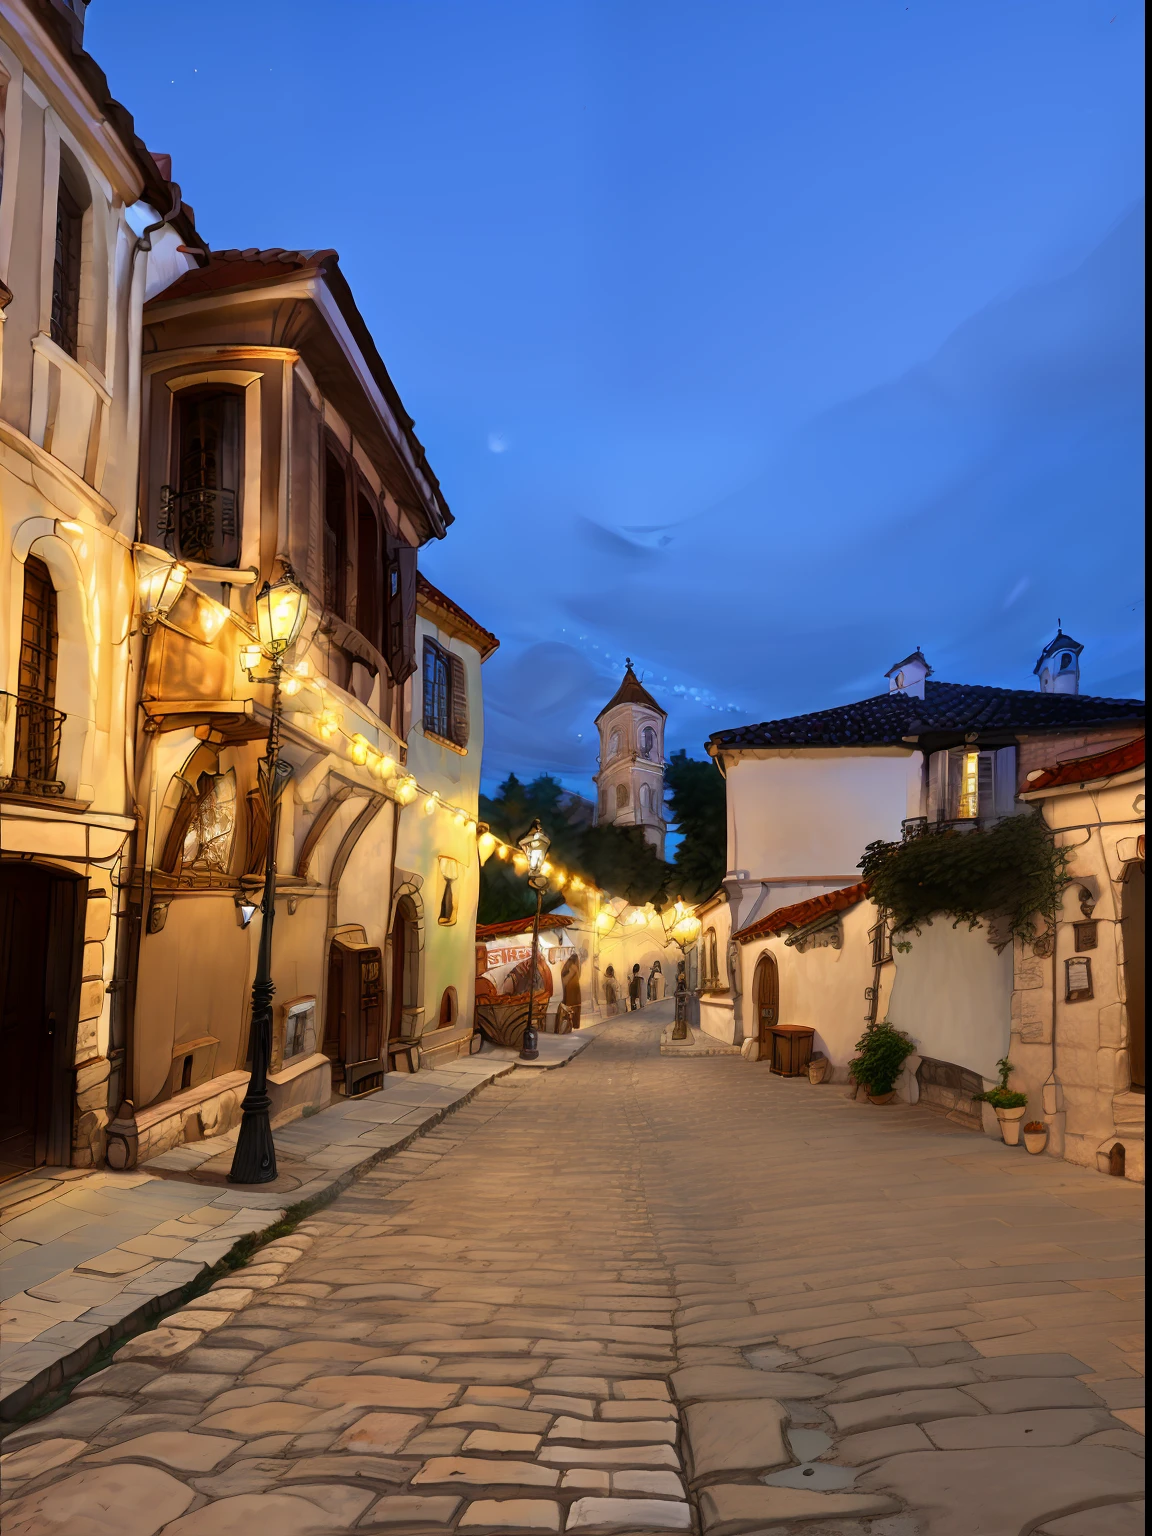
top-left (3, 1009), bottom-right (1143, 1536)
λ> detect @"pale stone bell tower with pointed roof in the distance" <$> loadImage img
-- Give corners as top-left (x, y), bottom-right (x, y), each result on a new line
top-left (596, 657), bottom-right (668, 859)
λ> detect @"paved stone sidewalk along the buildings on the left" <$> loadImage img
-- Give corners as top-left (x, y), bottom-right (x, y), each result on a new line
top-left (0, 1051), bottom-right (522, 1419)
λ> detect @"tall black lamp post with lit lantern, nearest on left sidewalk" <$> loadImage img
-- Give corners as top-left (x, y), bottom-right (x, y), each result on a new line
top-left (227, 567), bottom-right (309, 1184)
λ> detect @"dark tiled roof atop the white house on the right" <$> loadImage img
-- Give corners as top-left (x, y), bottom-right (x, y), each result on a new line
top-left (708, 679), bottom-right (1144, 756)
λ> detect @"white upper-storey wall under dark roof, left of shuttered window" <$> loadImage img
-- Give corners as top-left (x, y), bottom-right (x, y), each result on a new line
top-left (727, 746), bottom-right (923, 884)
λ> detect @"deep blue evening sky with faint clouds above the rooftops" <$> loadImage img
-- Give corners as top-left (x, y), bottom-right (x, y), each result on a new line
top-left (86, 0), bottom-right (1143, 791)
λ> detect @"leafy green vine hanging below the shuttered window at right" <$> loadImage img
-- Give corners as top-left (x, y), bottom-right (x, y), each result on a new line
top-left (859, 811), bottom-right (1068, 948)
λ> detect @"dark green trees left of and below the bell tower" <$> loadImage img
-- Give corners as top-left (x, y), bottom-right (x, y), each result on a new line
top-left (478, 774), bottom-right (671, 923)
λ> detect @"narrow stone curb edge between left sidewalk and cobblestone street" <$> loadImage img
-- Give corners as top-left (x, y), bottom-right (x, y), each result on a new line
top-left (0, 1040), bottom-right (516, 1435)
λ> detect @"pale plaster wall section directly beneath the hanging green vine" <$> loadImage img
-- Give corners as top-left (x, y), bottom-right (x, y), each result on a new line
top-left (890, 917), bottom-right (1012, 1080)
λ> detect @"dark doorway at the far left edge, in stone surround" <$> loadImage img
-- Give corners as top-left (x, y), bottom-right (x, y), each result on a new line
top-left (0, 860), bottom-right (84, 1180)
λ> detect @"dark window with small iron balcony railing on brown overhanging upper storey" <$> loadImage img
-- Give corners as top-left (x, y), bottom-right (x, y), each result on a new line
top-left (167, 389), bottom-right (243, 565)
